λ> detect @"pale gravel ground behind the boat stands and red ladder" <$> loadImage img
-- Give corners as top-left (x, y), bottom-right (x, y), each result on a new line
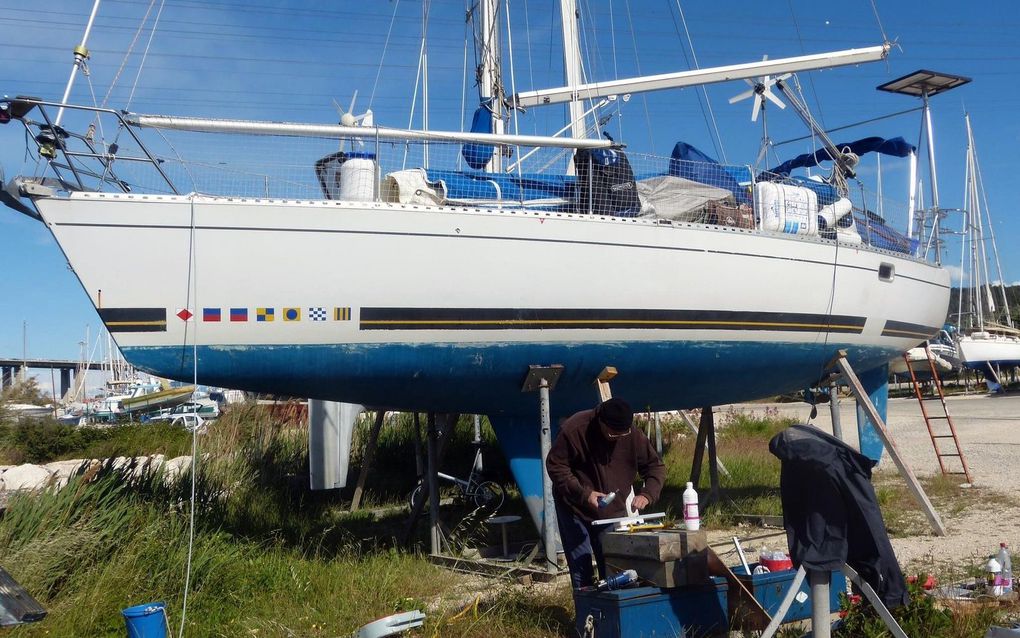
top-left (722, 394), bottom-right (1020, 566)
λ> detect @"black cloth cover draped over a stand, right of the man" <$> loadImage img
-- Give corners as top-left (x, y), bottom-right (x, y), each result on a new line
top-left (769, 426), bottom-right (907, 607)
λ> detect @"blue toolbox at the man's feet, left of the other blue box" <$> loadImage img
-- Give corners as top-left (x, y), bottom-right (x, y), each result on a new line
top-left (574, 578), bottom-right (729, 638)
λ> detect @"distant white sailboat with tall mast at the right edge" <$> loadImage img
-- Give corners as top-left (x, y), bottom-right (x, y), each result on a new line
top-left (957, 115), bottom-right (1020, 391)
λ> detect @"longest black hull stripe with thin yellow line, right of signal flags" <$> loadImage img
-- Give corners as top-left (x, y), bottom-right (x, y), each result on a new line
top-left (360, 308), bottom-right (867, 334)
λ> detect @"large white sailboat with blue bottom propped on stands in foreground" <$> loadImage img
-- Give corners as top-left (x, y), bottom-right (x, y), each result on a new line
top-left (0, 0), bottom-right (950, 521)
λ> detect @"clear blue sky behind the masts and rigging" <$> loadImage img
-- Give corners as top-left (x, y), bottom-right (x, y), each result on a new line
top-left (0, 0), bottom-right (1020, 358)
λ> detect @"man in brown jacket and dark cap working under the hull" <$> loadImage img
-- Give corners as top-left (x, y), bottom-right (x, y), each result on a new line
top-left (546, 398), bottom-right (666, 589)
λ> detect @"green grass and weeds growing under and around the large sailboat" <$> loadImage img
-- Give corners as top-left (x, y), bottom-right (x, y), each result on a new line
top-left (0, 396), bottom-right (1009, 638)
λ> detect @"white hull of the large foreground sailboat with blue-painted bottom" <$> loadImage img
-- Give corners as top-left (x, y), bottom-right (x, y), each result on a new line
top-left (36, 193), bottom-right (949, 411)
